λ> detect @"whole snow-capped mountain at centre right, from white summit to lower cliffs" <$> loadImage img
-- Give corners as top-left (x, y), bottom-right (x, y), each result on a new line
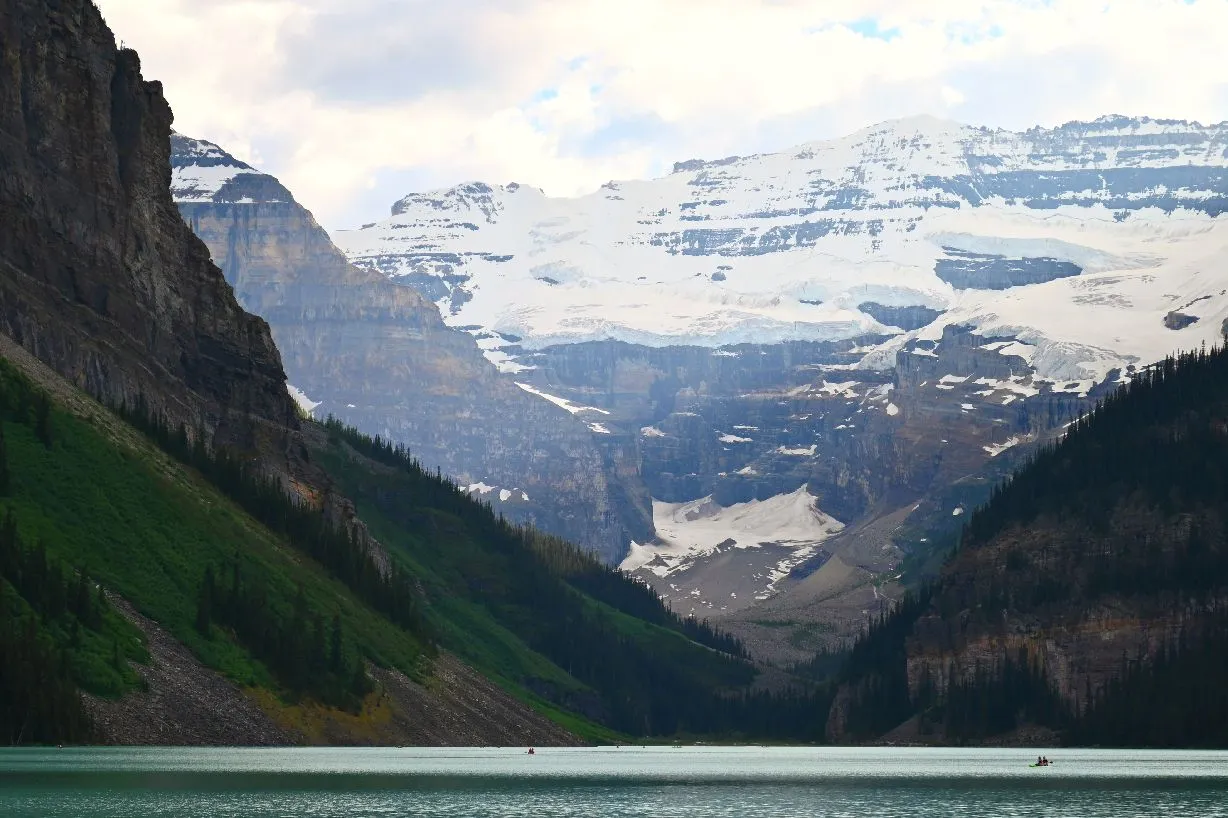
top-left (336, 117), bottom-right (1228, 638)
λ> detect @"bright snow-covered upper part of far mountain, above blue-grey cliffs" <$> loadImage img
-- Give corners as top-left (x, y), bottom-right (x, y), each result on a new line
top-left (336, 117), bottom-right (1228, 381)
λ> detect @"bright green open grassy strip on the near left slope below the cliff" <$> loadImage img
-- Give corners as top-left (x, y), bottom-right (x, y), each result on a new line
top-left (0, 361), bottom-right (425, 712)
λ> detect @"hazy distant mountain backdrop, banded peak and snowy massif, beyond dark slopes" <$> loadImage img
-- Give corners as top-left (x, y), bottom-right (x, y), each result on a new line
top-left (172, 111), bottom-right (1228, 661)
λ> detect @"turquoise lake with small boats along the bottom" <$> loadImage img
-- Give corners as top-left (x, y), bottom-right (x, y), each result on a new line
top-left (0, 747), bottom-right (1228, 818)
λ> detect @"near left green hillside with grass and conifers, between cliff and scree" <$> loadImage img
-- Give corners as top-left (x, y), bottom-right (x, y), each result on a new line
top-left (0, 360), bottom-right (431, 743)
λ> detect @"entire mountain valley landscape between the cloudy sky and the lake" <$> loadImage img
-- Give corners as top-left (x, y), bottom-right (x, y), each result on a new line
top-left (0, 0), bottom-right (1228, 752)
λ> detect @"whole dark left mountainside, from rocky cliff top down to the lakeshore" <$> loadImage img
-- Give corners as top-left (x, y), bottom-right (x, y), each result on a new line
top-left (0, 0), bottom-right (828, 744)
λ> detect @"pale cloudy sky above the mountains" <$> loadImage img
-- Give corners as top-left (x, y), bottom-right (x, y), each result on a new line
top-left (96, 0), bottom-right (1228, 228)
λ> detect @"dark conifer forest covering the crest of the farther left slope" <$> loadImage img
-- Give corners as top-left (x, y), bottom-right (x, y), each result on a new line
top-left (325, 418), bottom-right (800, 739)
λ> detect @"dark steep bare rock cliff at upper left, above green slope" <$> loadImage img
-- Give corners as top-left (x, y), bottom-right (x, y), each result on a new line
top-left (0, 0), bottom-right (297, 457)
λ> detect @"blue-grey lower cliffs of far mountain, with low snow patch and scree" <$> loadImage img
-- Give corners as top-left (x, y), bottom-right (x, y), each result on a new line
top-left (518, 327), bottom-right (1095, 623)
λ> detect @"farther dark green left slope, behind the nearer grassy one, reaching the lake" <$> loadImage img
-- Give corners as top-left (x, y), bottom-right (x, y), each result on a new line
top-left (313, 425), bottom-right (830, 737)
